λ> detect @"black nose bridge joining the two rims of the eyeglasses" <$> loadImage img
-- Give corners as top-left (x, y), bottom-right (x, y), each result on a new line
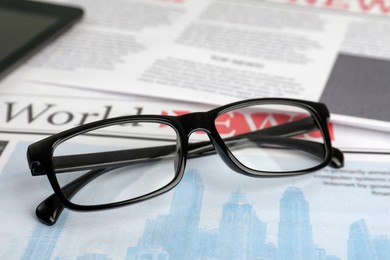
top-left (180, 112), bottom-right (211, 136)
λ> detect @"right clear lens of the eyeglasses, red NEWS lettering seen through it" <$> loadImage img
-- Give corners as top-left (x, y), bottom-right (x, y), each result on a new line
top-left (215, 103), bottom-right (326, 173)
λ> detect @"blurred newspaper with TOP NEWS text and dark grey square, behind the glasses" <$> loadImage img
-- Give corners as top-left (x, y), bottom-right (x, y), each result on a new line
top-left (10, 0), bottom-right (390, 130)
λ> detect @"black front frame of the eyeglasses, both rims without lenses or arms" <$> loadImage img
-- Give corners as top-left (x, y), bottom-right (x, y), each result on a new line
top-left (27, 98), bottom-right (332, 211)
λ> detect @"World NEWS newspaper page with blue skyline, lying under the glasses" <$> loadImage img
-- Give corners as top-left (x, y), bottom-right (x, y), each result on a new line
top-left (0, 95), bottom-right (390, 260)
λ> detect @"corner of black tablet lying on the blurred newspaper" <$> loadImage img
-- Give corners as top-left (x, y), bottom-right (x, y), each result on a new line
top-left (0, 0), bottom-right (83, 78)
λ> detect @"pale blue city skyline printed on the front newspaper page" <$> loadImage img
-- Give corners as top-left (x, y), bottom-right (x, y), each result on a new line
top-left (24, 170), bottom-right (390, 260)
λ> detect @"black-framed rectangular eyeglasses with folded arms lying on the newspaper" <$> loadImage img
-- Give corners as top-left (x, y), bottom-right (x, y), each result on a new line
top-left (27, 98), bottom-right (343, 225)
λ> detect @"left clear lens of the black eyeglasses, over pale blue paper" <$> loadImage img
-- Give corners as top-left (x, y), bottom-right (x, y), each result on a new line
top-left (53, 121), bottom-right (180, 206)
